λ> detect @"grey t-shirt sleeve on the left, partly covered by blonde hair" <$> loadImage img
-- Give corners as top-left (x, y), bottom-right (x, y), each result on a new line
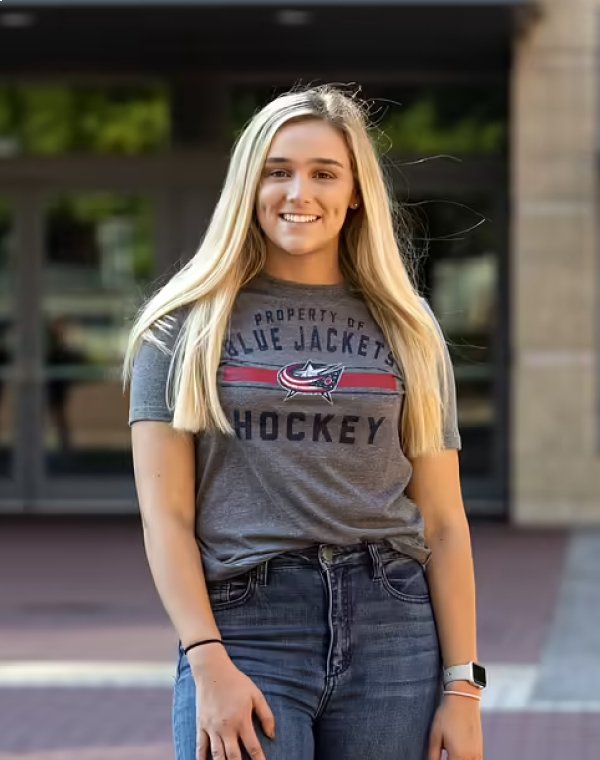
top-left (129, 315), bottom-right (181, 426)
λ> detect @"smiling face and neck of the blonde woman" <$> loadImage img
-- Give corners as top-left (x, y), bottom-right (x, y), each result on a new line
top-left (256, 119), bottom-right (358, 274)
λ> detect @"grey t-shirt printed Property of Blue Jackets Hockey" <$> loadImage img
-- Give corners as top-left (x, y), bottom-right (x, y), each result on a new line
top-left (129, 272), bottom-right (461, 580)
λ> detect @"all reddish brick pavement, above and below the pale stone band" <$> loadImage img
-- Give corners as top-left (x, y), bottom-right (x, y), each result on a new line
top-left (0, 518), bottom-right (600, 760)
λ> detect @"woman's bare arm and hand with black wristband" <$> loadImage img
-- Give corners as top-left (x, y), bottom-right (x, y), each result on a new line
top-left (132, 420), bottom-right (275, 760)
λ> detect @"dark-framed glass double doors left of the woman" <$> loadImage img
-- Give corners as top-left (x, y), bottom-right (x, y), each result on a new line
top-left (0, 153), bottom-right (222, 514)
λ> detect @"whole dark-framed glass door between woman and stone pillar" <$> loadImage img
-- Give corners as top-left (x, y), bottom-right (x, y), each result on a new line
top-left (412, 193), bottom-right (508, 516)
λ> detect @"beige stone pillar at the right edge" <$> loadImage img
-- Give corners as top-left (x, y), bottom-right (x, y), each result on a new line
top-left (510, 0), bottom-right (600, 525)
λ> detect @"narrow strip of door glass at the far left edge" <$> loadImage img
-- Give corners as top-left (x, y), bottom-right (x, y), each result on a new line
top-left (0, 198), bottom-right (15, 478)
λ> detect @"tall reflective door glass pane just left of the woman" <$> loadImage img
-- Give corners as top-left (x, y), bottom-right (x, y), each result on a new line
top-left (43, 194), bottom-right (154, 476)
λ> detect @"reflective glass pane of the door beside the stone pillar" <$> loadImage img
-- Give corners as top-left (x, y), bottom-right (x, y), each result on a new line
top-left (412, 199), bottom-right (498, 476)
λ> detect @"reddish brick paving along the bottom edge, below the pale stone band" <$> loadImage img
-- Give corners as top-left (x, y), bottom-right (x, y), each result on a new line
top-left (0, 690), bottom-right (600, 760)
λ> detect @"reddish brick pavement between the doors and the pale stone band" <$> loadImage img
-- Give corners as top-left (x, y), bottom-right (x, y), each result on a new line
top-left (0, 517), bottom-right (568, 663)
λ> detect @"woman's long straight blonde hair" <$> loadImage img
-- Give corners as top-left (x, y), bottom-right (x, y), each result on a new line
top-left (123, 86), bottom-right (448, 457)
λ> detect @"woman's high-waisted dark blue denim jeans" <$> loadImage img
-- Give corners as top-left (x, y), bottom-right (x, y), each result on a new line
top-left (173, 542), bottom-right (442, 760)
